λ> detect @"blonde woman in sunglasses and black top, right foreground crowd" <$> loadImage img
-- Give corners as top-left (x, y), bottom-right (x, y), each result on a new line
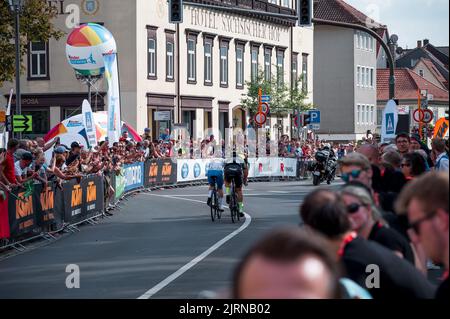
top-left (341, 186), bottom-right (415, 265)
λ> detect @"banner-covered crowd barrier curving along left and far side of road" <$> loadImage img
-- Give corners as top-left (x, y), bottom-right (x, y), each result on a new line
top-left (0, 159), bottom-right (311, 252)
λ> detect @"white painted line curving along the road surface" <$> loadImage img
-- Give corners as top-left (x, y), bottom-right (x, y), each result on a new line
top-left (137, 194), bottom-right (252, 299)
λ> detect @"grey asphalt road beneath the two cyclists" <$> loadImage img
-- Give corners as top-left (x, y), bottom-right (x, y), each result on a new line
top-left (0, 182), bottom-right (338, 299)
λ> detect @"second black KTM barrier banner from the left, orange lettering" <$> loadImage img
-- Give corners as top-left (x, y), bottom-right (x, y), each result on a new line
top-left (33, 183), bottom-right (64, 227)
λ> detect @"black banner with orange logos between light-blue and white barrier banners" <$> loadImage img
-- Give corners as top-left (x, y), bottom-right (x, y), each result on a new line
top-left (145, 159), bottom-right (177, 187)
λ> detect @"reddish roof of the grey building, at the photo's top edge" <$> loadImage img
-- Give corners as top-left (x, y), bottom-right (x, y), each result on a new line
top-left (314, 0), bottom-right (382, 27)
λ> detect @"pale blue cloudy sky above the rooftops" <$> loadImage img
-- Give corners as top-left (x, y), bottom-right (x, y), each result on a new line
top-left (345, 0), bottom-right (449, 48)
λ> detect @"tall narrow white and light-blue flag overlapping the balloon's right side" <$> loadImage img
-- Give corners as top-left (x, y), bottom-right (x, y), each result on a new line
top-left (103, 53), bottom-right (121, 145)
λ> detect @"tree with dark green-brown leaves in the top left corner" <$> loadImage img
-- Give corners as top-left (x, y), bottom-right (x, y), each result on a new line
top-left (0, 0), bottom-right (64, 86)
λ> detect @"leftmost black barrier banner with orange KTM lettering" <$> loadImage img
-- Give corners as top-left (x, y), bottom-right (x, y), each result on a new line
top-left (8, 189), bottom-right (37, 238)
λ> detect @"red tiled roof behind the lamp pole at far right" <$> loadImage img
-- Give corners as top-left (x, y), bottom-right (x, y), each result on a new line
top-left (377, 68), bottom-right (448, 102)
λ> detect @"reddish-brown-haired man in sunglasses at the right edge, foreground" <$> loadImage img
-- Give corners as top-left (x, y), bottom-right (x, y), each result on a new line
top-left (396, 172), bottom-right (450, 301)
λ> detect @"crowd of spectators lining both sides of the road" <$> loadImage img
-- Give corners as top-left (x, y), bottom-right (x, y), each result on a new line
top-left (0, 129), bottom-right (449, 300)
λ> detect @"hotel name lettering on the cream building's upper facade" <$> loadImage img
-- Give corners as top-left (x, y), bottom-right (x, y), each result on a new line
top-left (188, 7), bottom-right (285, 42)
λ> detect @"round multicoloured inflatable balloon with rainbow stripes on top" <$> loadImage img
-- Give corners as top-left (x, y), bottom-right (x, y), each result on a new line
top-left (66, 23), bottom-right (117, 76)
